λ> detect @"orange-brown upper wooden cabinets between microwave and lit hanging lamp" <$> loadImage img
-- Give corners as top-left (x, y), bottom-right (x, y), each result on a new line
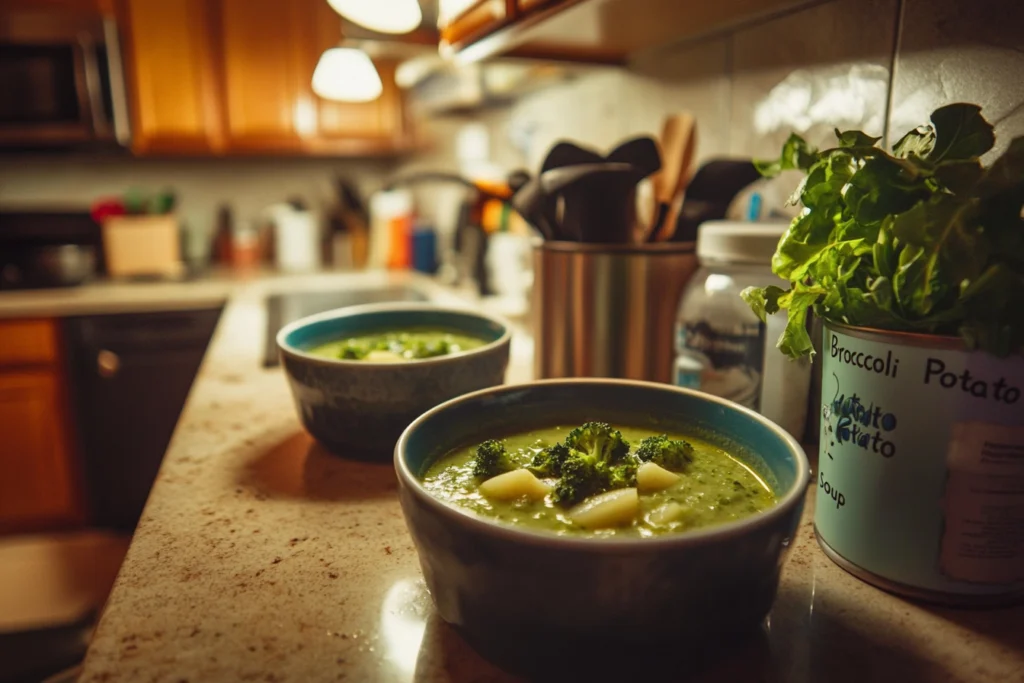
top-left (120, 0), bottom-right (409, 156)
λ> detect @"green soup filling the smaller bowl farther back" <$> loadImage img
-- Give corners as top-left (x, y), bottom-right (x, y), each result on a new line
top-left (308, 328), bottom-right (487, 362)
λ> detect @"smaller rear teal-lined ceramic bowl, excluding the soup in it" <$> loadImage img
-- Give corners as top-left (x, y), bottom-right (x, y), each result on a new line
top-left (278, 303), bottom-right (511, 460)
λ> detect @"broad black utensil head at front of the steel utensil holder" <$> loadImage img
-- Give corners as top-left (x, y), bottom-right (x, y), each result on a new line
top-left (541, 162), bottom-right (644, 244)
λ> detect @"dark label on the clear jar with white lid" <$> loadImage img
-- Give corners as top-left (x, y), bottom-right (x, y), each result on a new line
top-left (677, 321), bottom-right (765, 410)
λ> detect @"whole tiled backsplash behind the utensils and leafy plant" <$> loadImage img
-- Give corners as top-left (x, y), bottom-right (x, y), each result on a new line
top-left (456, 0), bottom-right (1024, 216)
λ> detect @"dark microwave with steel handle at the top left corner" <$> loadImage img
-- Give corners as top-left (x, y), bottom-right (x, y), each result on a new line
top-left (0, 9), bottom-right (130, 148)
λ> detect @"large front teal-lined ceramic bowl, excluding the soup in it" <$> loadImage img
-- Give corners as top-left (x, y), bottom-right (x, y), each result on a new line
top-left (395, 380), bottom-right (810, 657)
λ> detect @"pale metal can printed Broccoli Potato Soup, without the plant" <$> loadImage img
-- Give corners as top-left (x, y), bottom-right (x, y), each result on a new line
top-left (814, 322), bottom-right (1024, 604)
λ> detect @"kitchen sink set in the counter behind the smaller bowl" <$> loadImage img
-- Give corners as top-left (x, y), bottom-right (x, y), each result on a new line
top-left (263, 287), bottom-right (429, 368)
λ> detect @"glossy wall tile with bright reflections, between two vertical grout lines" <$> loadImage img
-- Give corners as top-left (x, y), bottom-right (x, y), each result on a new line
top-left (729, 0), bottom-right (898, 212)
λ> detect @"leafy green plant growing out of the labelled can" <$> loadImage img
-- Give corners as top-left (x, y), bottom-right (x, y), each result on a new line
top-left (742, 103), bottom-right (1024, 357)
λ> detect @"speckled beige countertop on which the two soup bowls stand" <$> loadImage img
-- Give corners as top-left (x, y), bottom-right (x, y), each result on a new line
top-left (74, 278), bottom-right (1024, 683)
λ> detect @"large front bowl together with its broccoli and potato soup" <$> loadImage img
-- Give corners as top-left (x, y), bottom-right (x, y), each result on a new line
top-left (395, 379), bottom-right (809, 654)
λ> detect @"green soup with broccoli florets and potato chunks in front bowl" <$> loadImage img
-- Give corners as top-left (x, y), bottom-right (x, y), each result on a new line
top-left (423, 422), bottom-right (776, 537)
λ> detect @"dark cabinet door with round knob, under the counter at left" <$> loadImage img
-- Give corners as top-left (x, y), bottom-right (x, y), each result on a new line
top-left (67, 310), bottom-right (219, 530)
